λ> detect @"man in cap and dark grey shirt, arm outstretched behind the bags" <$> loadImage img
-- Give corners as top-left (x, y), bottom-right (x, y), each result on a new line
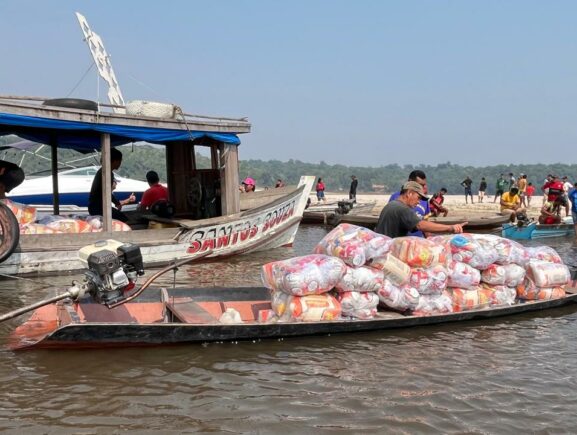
top-left (375, 181), bottom-right (467, 238)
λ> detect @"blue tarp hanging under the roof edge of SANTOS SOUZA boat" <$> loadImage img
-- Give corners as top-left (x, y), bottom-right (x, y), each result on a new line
top-left (0, 113), bottom-right (240, 151)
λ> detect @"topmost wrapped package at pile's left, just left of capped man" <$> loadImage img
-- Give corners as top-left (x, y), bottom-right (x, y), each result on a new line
top-left (314, 224), bottom-right (392, 267)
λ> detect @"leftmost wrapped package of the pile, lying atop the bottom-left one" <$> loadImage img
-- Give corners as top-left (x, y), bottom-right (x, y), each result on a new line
top-left (261, 254), bottom-right (347, 296)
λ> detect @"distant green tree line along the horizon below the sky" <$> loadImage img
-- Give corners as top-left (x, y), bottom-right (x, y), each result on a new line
top-left (0, 136), bottom-right (577, 194)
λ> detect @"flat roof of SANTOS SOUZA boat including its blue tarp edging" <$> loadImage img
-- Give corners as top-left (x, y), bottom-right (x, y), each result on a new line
top-left (0, 96), bottom-right (251, 151)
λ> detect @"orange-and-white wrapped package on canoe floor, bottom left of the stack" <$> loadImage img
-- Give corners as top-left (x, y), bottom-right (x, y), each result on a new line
top-left (271, 291), bottom-right (341, 322)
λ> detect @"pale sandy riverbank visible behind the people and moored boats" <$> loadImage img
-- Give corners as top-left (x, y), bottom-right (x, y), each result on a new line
top-left (311, 192), bottom-right (542, 217)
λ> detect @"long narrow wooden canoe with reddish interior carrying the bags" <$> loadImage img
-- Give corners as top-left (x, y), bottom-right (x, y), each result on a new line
top-left (9, 287), bottom-right (577, 349)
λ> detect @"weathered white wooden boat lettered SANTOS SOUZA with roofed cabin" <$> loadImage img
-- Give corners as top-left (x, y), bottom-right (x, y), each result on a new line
top-left (0, 96), bottom-right (314, 275)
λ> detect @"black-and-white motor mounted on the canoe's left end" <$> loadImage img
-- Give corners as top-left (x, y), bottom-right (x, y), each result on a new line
top-left (78, 240), bottom-right (144, 305)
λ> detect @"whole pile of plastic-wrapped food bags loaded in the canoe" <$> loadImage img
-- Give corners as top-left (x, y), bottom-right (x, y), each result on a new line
top-left (263, 224), bottom-right (569, 320)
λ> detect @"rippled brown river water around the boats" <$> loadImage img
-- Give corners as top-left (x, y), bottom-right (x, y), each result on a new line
top-left (0, 226), bottom-right (577, 434)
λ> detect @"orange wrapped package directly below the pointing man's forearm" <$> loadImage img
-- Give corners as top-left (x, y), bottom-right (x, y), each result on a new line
top-left (391, 236), bottom-right (447, 268)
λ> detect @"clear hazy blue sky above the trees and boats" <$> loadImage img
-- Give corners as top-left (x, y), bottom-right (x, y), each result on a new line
top-left (0, 0), bottom-right (577, 166)
